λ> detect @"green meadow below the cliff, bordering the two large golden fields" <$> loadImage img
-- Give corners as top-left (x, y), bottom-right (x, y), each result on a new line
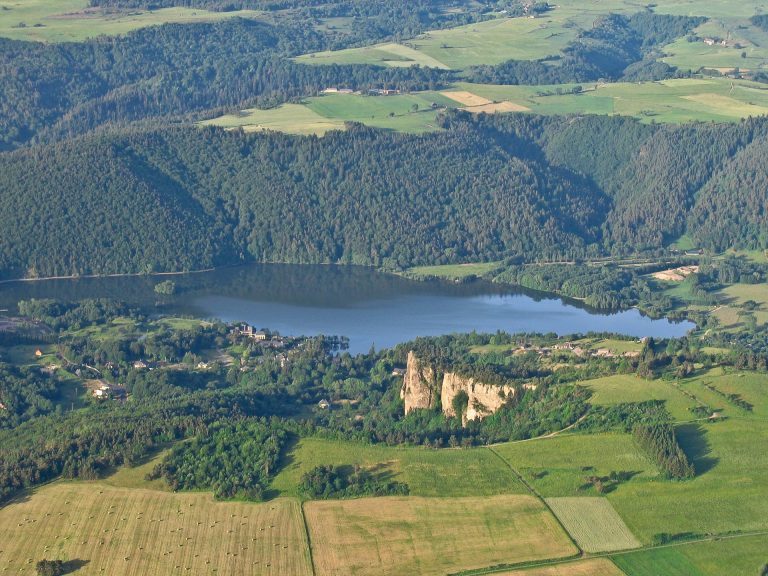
top-left (270, 438), bottom-right (527, 497)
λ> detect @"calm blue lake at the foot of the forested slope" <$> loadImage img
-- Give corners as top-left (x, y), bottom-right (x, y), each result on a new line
top-left (0, 264), bottom-right (694, 352)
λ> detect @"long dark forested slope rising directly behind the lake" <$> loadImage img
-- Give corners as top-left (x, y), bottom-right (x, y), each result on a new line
top-left (0, 113), bottom-right (768, 277)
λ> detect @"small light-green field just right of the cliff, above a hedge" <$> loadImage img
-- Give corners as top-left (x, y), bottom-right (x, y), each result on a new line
top-left (581, 374), bottom-right (697, 421)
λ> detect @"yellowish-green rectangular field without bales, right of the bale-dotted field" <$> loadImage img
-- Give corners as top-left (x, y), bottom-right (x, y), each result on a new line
top-left (304, 495), bottom-right (576, 576)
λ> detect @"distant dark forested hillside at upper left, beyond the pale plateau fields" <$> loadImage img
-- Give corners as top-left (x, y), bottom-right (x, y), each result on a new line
top-left (0, 19), bottom-right (445, 150)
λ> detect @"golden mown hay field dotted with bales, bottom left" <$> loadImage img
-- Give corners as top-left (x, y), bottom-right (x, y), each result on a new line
top-left (0, 482), bottom-right (312, 576)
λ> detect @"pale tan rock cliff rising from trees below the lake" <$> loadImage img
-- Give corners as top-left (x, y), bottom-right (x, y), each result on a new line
top-left (400, 352), bottom-right (515, 423)
